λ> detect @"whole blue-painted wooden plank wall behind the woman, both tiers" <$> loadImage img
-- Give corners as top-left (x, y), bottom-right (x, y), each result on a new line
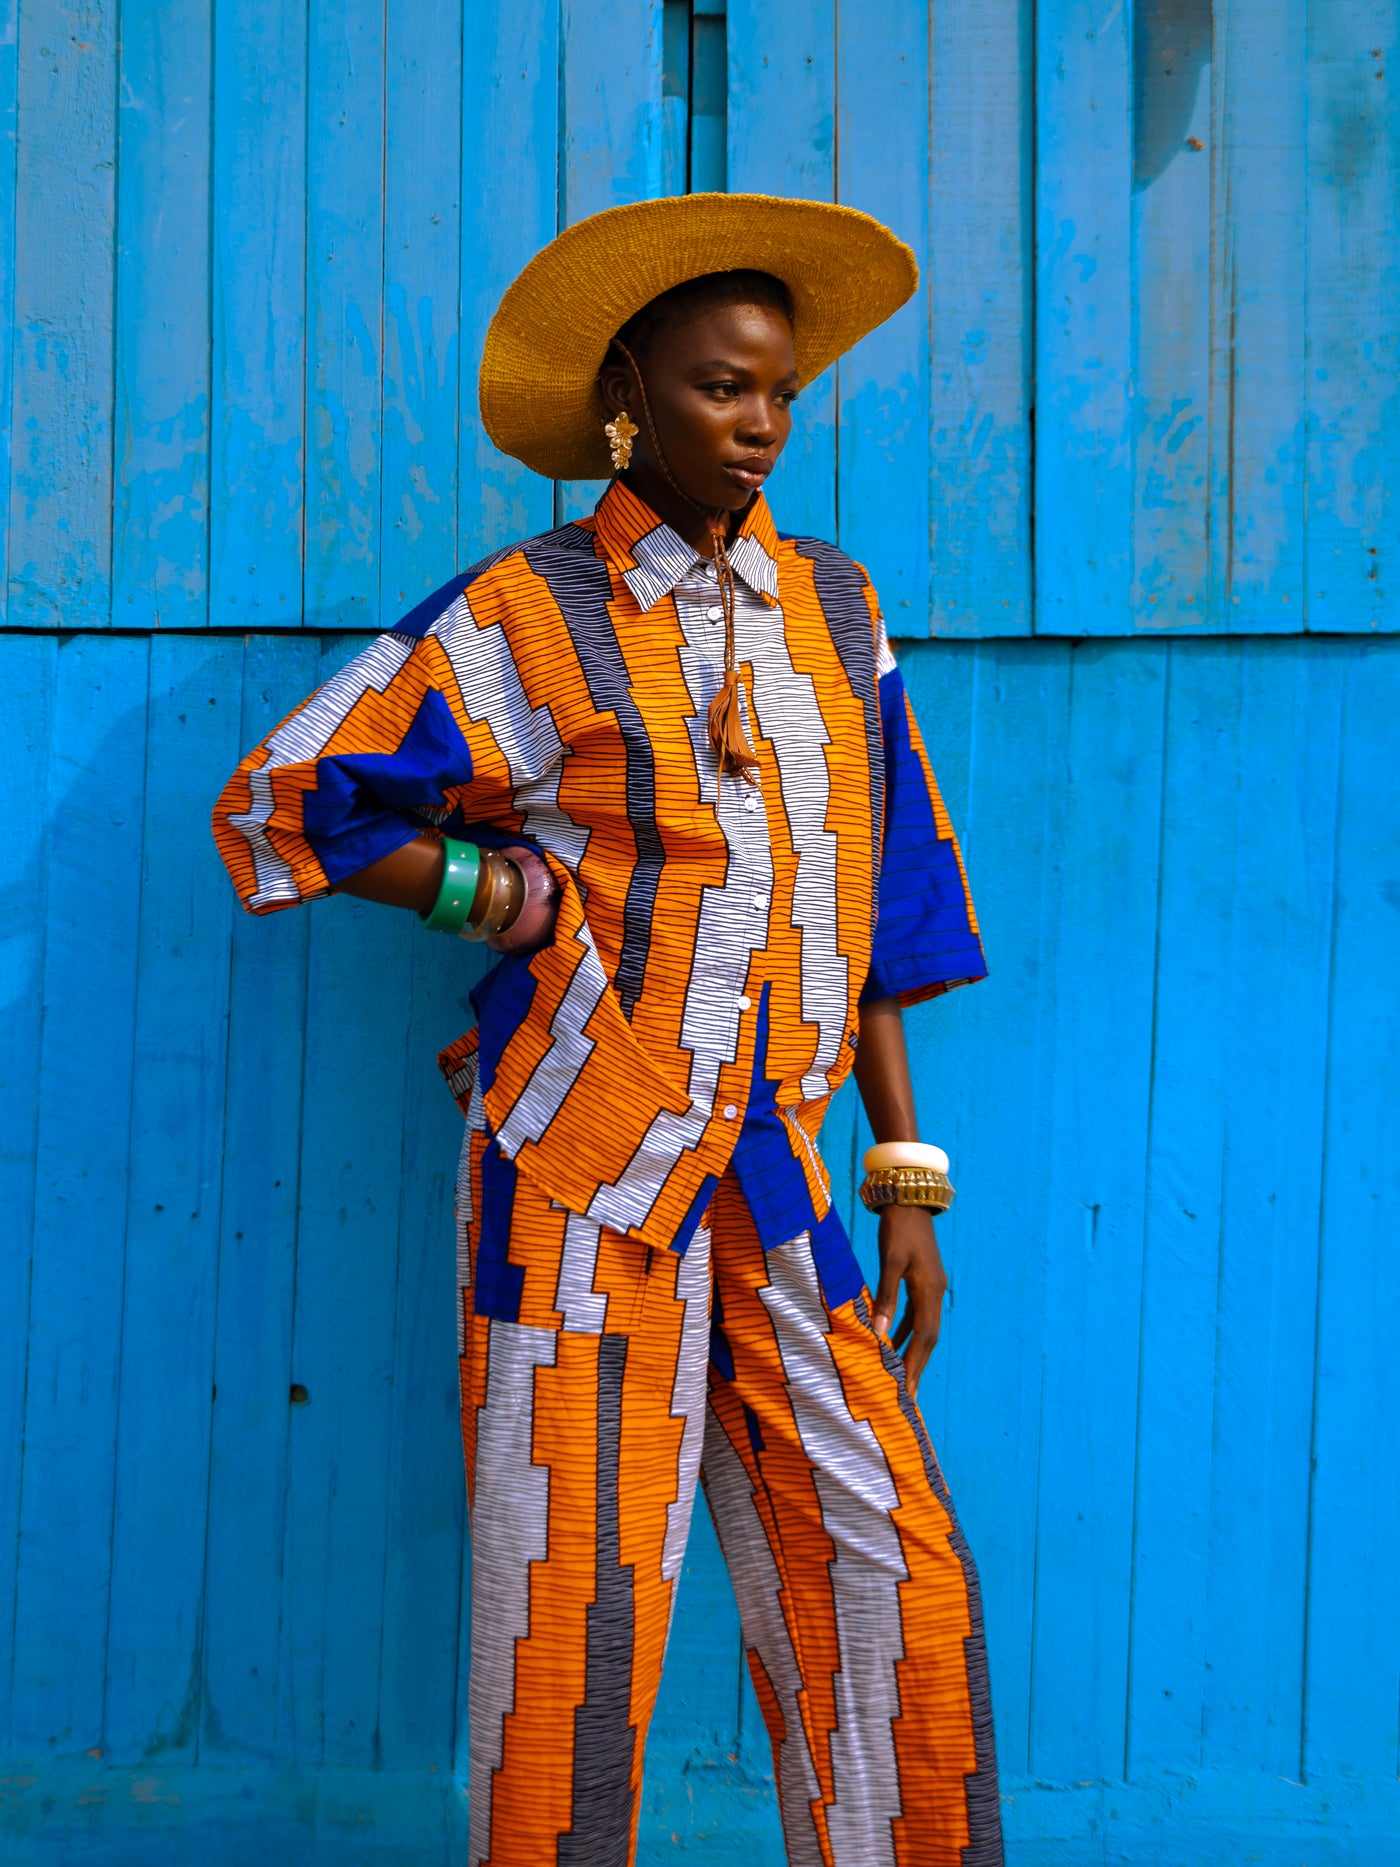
top-left (0, 0), bottom-right (1400, 1867)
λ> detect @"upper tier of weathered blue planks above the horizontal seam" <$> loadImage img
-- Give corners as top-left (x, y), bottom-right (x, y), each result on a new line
top-left (0, 0), bottom-right (1400, 637)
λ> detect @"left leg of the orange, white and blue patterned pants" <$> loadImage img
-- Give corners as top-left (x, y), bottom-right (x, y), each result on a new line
top-left (459, 1133), bottom-right (709, 1867)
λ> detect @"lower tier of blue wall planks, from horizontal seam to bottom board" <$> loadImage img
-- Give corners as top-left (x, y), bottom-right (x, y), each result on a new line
top-left (0, 635), bottom-right (1400, 1861)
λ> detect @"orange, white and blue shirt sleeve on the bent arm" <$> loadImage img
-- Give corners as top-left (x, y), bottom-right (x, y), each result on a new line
top-left (213, 579), bottom-right (521, 913)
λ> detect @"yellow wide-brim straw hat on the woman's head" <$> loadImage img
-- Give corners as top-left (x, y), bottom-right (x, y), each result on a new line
top-left (482, 194), bottom-right (918, 480)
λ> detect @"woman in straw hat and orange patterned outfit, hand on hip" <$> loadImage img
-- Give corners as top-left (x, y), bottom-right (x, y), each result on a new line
top-left (215, 196), bottom-right (1001, 1867)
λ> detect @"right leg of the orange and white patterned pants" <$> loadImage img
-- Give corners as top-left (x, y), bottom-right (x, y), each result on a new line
top-left (704, 1176), bottom-right (1002, 1867)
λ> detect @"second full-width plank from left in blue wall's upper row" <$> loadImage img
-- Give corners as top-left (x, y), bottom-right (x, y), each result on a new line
top-left (112, 0), bottom-right (211, 629)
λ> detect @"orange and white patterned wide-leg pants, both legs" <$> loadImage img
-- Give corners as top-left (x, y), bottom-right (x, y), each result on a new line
top-left (459, 1135), bottom-right (1002, 1867)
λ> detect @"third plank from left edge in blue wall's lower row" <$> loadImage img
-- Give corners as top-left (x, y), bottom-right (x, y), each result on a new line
top-left (105, 637), bottom-right (243, 1762)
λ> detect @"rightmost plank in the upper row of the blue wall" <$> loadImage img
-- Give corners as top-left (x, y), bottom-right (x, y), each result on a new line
top-left (1307, 0), bottom-right (1400, 631)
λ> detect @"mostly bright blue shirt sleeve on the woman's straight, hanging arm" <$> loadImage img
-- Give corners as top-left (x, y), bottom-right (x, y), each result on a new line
top-left (861, 616), bottom-right (987, 1004)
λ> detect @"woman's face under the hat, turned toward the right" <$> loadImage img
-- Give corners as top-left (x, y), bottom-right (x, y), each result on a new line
top-left (601, 304), bottom-right (797, 528)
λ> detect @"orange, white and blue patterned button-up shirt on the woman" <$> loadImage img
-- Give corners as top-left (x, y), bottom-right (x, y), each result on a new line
top-left (215, 482), bottom-right (986, 1249)
